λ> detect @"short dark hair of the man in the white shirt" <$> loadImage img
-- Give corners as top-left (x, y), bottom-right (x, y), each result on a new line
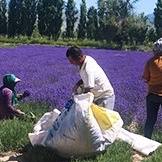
top-left (66, 46), bottom-right (84, 60)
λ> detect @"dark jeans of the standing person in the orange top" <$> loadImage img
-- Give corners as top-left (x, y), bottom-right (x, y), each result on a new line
top-left (144, 93), bottom-right (162, 139)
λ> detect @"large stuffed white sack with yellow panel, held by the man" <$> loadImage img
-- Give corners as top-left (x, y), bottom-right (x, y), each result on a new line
top-left (29, 93), bottom-right (123, 158)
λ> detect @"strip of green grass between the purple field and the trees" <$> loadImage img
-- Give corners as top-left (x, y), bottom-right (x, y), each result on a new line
top-left (0, 36), bottom-right (152, 51)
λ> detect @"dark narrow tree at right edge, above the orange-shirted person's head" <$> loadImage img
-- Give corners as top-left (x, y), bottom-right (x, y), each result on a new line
top-left (154, 0), bottom-right (162, 38)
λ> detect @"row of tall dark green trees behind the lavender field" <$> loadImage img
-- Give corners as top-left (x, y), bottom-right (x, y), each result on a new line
top-left (0, 0), bottom-right (162, 47)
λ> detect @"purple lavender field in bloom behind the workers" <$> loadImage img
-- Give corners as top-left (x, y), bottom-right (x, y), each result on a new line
top-left (0, 45), bottom-right (162, 132)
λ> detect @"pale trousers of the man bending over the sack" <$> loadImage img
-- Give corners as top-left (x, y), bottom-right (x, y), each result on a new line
top-left (94, 95), bottom-right (115, 110)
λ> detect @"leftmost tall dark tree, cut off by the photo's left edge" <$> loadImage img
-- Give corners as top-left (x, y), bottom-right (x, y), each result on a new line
top-left (0, 0), bottom-right (7, 35)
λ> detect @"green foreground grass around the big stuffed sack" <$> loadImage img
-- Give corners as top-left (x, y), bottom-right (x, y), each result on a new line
top-left (0, 103), bottom-right (162, 162)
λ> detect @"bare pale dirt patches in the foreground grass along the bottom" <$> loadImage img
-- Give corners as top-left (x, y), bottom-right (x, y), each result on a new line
top-left (0, 151), bottom-right (145, 162)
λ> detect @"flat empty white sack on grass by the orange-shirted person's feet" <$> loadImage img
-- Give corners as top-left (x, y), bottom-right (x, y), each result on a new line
top-left (118, 128), bottom-right (161, 156)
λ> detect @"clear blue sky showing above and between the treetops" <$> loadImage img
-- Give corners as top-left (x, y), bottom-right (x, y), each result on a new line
top-left (74, 0), bottom-right (157, 15)
